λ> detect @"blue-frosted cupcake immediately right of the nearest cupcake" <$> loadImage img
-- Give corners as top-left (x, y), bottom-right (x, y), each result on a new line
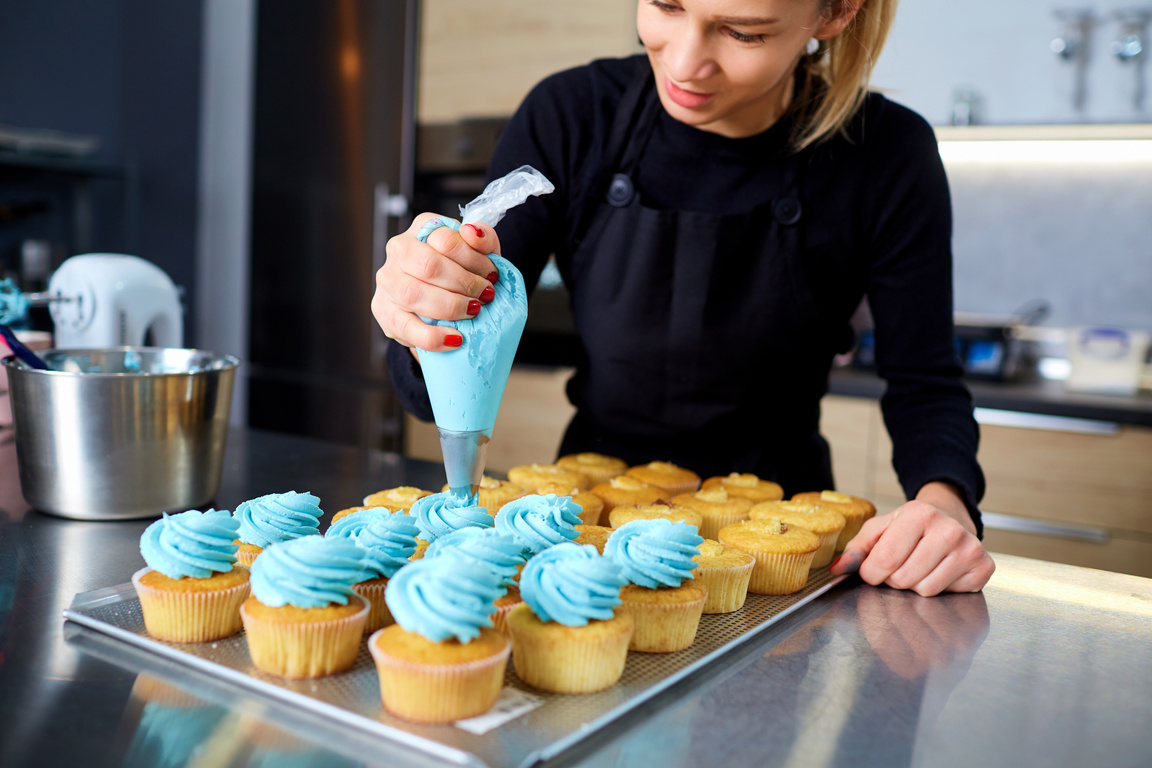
top-left (508, 543), bottom-right (635, 693)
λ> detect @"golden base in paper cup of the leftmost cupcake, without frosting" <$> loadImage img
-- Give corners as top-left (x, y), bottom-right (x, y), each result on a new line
top-left (132, 568), bottom-right (251, 642)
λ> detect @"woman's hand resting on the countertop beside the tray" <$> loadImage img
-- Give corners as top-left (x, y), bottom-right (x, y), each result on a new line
top-left (831, 482), bottom-right (995, 596)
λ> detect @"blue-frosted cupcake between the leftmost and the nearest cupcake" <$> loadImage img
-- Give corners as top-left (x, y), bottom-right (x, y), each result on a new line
top-left (240, 535), bottom-right (369, 678)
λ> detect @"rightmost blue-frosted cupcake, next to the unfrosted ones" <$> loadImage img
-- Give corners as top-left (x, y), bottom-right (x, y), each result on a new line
top-left (604, 520), bottom-right (707, 653)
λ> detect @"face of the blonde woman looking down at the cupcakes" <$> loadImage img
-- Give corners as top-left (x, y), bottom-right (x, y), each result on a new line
top-left (636, 0), bottom-right (847, 138)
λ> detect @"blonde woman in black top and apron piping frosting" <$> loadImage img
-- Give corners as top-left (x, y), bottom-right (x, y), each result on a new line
top-left (372, 0), bottom-right (993, 594)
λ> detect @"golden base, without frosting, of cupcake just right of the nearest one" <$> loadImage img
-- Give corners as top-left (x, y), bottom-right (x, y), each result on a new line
top-left (509, 611), bottom-right (635, 693)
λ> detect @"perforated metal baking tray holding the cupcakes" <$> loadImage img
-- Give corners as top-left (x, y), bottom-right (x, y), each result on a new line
top-left (65, 569), bottom-right (846, 768)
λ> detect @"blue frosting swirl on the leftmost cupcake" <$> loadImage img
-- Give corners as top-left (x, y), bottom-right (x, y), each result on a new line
top-left (141, 509), bottom-right (240, 579)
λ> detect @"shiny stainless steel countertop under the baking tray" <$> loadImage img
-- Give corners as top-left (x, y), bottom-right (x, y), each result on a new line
top-left (0, 429), bottom-right (1152, 768)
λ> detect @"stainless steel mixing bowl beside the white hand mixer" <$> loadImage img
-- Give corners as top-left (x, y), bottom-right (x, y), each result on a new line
top-left (2, 347), bottom-right (240, 520)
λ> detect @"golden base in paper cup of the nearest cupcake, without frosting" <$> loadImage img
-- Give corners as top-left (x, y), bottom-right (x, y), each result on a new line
top-left (367, 630), bottom-right (511, 724)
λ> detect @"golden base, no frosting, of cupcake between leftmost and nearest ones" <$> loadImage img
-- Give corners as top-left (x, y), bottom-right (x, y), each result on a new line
top-left (240, 595), bottom-right (369, 678)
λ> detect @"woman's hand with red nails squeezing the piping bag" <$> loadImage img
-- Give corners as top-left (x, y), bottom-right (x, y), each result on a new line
top-left (372, 213), bottom-right (500, 352)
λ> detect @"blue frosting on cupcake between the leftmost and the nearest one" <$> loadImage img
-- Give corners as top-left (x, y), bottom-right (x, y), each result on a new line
top-left (252, 535), bottom-right (364, 608)
